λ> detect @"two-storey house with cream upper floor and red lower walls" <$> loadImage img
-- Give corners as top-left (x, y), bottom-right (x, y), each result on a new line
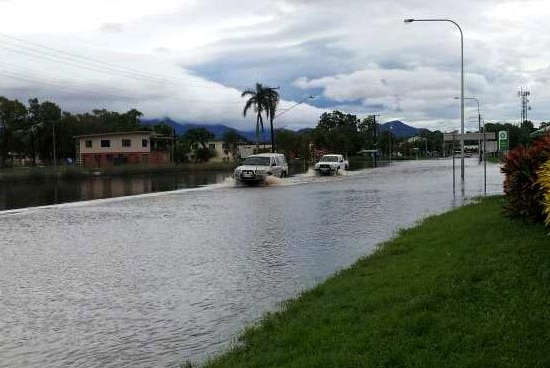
top-left (74, 131), bottom-right (174, 167)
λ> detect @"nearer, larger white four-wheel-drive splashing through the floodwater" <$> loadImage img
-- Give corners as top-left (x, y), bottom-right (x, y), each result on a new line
top-left (233, 153), bottom-right (288, 184)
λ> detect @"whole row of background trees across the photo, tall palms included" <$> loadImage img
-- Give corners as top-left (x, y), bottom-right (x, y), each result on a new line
top-left (0, 92), bottom-right (535, 167)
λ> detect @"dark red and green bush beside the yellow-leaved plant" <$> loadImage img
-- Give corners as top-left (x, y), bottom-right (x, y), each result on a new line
top-left (501, 135), bottom-right (550, 222)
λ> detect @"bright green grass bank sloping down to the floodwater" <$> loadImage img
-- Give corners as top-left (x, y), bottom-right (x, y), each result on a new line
top-left (206, 197), bottom-right (550, 368)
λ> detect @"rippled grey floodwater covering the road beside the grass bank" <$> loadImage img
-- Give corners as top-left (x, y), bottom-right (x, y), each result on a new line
top-left (0, 159), bottom-right (502, 368)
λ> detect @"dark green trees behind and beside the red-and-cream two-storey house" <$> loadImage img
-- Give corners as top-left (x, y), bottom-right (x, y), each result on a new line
top-left (0, 97), bottom-right (248, 167)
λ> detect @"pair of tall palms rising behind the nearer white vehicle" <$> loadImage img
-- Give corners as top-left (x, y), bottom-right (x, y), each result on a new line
top-left (241, 83), bottom-right (279, 151)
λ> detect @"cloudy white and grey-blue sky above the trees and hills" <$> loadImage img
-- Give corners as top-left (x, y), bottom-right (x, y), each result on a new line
top-left (0, 0), bottom-right (550, 130)
